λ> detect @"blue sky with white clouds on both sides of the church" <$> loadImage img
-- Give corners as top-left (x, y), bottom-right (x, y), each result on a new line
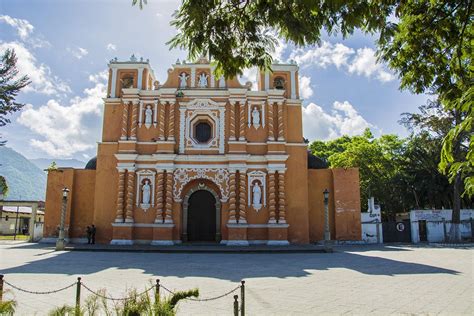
top-left (0, 0), bottom-right (427, 161)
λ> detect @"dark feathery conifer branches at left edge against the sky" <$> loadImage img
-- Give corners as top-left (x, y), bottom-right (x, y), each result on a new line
top-left (0, 49), bottom-right (30, 146)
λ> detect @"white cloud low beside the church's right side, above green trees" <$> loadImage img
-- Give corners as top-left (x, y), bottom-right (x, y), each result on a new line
top-left (303, 101), bottom-right (374, 141)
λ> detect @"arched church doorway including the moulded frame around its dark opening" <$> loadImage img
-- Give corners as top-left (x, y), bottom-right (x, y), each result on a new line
top-left (182, 184), bottom-right (221, 242)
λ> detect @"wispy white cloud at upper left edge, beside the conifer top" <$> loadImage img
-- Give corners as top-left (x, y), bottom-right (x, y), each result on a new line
top-left (0, 42), bottom-right (71, 95)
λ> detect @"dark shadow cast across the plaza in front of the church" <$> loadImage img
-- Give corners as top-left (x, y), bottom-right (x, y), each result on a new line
top-left (0, 244), bottom-right (459, 282)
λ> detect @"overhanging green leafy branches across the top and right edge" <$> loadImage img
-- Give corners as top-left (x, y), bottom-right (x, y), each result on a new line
top-left (139, 0), bottom-right (474, 195)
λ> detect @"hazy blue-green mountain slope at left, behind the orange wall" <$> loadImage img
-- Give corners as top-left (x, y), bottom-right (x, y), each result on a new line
top-left (0, 146), bottom-right (46, 201)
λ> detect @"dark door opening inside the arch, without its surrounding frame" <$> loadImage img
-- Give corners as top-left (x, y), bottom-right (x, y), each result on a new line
top-left (187, 190), bottom-right (216, 241)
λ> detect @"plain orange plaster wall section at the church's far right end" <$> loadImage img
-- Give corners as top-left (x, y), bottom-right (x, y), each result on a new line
top-left (332, 168), bottom-right (361, 240)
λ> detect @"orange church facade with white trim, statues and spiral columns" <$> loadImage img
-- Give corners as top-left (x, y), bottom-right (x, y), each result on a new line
top-left (44, 56), bottom-right (360, 245)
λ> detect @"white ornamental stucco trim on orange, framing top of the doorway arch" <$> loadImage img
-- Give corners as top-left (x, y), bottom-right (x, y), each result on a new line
top-left (173, 168), bottom-right (229, 202)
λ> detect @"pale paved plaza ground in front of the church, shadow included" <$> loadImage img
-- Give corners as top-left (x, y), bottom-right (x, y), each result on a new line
top-left (0, 241), bottom-right (474, 315)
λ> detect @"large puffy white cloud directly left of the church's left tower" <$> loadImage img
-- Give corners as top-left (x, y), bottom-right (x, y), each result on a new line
top-left (17, 72), bottom-right (106, 158)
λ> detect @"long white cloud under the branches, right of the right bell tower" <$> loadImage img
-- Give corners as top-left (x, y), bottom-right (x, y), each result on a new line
top-left (290, 41), bottom-right (395, 82)
